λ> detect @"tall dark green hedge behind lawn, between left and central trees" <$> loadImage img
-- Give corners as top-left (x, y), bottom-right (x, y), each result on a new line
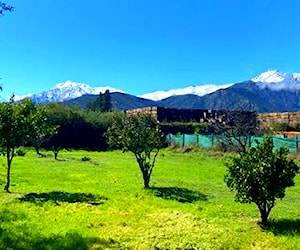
top-left (42, 104), bottom-right (115, 151)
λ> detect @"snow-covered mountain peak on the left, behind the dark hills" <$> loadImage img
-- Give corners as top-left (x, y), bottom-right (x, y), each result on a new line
top-left (15, 80), bottom-right (124, 103)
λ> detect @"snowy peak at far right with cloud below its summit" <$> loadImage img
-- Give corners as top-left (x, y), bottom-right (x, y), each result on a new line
top-left (251, 70), bottom-right (300, 90)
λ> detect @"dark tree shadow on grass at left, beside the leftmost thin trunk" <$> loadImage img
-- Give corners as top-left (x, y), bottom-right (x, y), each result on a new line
top-left (19, 191), bottom-right (108, 205)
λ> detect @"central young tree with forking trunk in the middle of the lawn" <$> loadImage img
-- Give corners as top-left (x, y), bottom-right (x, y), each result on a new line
top-left (107, 114), bottom-right (164, 188)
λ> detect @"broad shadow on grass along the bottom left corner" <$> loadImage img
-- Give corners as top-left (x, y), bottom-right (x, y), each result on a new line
top-left (0, 228), bottom-right (119, 250)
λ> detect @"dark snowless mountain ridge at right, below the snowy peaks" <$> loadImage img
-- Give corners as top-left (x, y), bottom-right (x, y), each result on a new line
top-left (162, 81), bottom-right (300, 112)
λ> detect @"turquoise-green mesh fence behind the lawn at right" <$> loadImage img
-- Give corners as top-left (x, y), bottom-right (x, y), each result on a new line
top-left (167, 134), bottom-right (300, 153)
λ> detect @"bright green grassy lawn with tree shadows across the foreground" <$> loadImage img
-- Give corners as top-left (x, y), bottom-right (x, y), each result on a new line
top-left (0, 150), bottom-right (300, 249)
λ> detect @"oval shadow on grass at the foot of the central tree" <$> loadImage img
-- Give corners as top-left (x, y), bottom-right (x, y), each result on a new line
top-left (150, 187), bottom-right (208, 203)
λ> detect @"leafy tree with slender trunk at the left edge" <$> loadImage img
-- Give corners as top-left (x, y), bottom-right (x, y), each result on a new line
top-left (0, 97), bottom-right (34, 192)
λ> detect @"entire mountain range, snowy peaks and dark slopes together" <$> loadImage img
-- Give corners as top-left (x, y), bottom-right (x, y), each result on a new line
top-left (17, 70), bottom-right (300, 112)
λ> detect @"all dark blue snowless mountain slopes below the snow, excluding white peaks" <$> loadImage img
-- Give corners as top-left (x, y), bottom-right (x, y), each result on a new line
top-left (65, 81), bottom-right (300, 112)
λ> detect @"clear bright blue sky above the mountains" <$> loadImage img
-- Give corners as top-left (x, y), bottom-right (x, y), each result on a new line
top-left (0, 0), bottom-right (300, 97)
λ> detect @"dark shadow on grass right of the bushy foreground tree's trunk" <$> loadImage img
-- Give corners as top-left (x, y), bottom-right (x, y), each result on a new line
top-left (264, 219), bottom-right (300, 236)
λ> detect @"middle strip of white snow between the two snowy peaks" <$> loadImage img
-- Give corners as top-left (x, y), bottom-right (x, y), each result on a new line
top-left (139, 84), bottom-right (233, 101)
